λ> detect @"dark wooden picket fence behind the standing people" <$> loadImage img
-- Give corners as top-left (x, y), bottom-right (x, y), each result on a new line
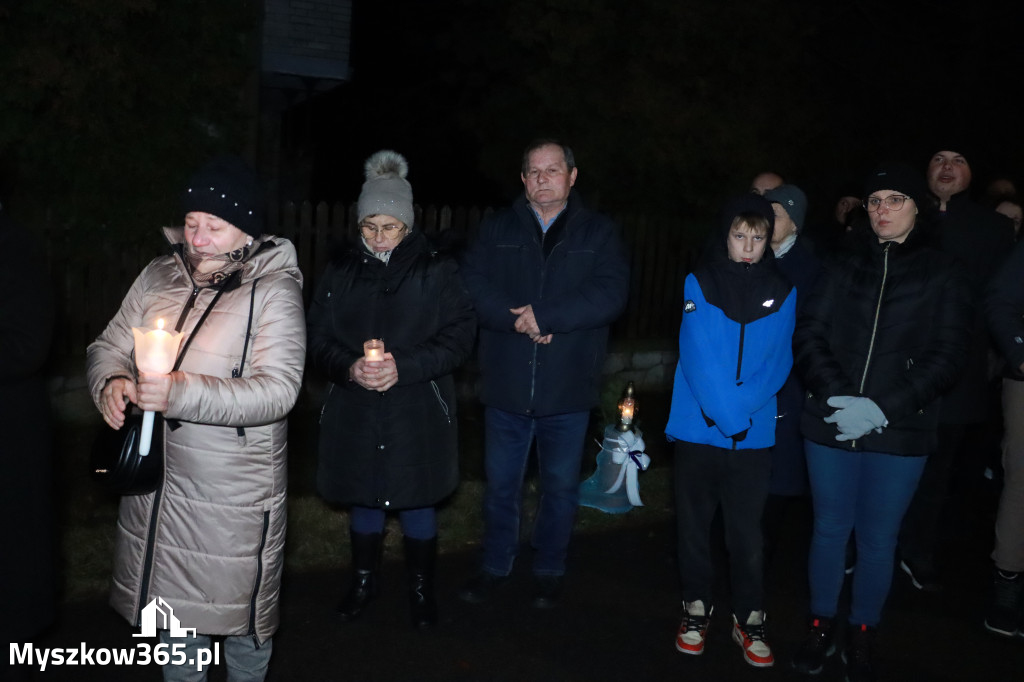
top-left (45, 202), bottom-right (694, 361)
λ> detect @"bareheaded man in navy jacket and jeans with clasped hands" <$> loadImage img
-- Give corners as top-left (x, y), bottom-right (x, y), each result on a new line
top-left (460, 139), bottom-right (630, 608)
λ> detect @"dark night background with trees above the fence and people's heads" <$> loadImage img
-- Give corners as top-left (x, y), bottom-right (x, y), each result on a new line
top-left (0, 0), bottom-right (1024, 242)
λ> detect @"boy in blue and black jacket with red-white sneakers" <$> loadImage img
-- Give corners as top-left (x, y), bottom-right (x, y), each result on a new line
top-left (666, 195), bottom-right (797, 668)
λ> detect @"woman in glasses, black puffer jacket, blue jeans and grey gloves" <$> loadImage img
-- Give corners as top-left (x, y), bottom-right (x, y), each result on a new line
top-left (794, 164), bottom-right (973, 682)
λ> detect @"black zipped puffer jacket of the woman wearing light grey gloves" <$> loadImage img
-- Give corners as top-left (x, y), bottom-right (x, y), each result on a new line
top-left (794, 226), bottom-right (974, 455)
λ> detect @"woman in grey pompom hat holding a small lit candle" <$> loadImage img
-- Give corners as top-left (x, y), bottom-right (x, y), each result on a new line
top-left (307, 151), bottom-right (476, 627)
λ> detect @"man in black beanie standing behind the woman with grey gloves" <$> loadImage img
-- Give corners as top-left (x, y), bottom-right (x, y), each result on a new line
top-left (900, 145), bottom-right (1014, 592)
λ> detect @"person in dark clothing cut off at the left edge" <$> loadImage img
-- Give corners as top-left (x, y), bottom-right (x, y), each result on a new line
top-left (0, 205), bottom-right (56, 655)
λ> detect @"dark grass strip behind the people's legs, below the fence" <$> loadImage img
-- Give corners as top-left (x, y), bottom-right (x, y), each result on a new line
top-left (56, 403), bottom-right (672, 601)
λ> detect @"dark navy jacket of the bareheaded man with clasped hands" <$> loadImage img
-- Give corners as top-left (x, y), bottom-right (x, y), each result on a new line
top-left (462, 193), bottom-right (630, 417)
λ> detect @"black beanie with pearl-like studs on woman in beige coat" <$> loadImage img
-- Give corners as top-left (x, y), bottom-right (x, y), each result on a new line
top-left (181, 156), bottom-right (263, 238)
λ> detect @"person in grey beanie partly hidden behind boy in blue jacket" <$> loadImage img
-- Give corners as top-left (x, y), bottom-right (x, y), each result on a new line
top-left (763, 184), bottom-right (821, 565)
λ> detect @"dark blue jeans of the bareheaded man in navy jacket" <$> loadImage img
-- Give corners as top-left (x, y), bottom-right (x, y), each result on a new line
top-left (481, 408), bottom-right (590, 576)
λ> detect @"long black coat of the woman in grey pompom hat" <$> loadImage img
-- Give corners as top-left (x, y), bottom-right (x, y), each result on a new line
top-left (308, 231), bottom-right (476, 509)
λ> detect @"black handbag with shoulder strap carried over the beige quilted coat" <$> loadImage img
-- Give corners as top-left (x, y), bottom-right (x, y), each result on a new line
top-left (89, 271), bottom-right (239, 495)
